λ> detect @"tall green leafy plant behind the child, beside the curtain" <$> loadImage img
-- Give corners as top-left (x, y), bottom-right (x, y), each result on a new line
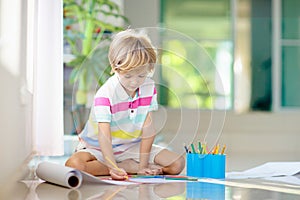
top-left (63, 0), bottom-right (128, 132)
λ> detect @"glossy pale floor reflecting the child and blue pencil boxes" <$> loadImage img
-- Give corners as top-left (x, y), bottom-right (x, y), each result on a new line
top-left (0, 135), bottom-right (300, 200)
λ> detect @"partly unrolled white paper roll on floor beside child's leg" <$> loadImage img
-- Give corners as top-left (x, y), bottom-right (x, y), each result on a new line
top-left (36, 162), bottom-right (137, 189)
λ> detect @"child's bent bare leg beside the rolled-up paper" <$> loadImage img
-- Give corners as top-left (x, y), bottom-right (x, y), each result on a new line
top-left (65, 151), bottom-right (109, 176)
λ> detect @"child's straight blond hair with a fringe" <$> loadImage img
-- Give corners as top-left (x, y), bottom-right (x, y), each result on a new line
top-left (108, 29), bottom-right (156, 73)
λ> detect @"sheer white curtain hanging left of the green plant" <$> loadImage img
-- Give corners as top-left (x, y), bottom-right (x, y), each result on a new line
top-left (32, 0), bottom-right (64, 156)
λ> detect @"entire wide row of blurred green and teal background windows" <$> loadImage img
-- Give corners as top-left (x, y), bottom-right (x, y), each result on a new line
top-left (160, 0), bottom-right (300, 111)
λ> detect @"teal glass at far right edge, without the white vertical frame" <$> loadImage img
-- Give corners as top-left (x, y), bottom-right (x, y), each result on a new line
top-left (280, 0), bottom-right (300, 108)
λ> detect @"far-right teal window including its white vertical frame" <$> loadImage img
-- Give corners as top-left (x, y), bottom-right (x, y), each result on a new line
top-left (272, 0), bottom-right (300, 111)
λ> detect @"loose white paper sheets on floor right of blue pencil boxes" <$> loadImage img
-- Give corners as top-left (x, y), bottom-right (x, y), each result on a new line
top-left (226, 162), bottom-right (300, 179)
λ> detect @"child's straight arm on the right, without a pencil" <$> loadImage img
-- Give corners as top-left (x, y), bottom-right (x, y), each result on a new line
top-left (139, 113), bottom-right (156, 171)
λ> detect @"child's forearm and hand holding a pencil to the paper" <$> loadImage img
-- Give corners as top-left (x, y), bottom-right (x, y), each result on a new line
top-left (98, 122), bottom-right (127, 179)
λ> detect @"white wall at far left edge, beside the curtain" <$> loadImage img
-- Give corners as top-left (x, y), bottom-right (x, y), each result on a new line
top-left (0, 0), bottom-right (31, 196)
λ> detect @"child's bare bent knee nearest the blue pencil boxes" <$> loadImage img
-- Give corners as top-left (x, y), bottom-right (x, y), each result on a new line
top-left (154, 149), bottom-right (185, 175)
